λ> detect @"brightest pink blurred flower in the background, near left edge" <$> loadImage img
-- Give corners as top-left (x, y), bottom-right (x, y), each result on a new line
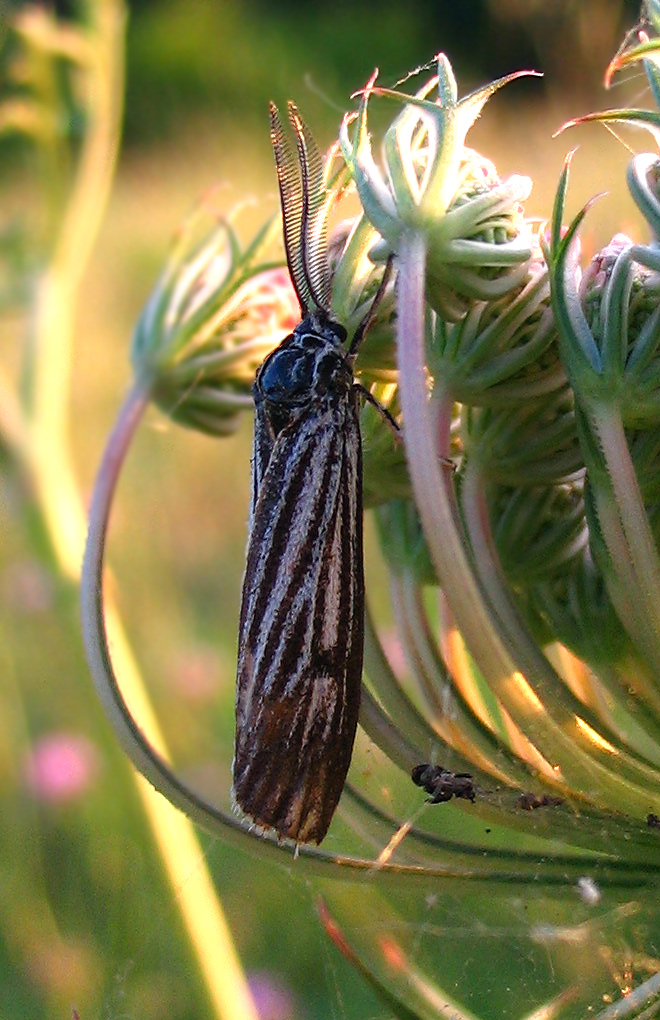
top-left (23, 733), bottom-right (99, 804)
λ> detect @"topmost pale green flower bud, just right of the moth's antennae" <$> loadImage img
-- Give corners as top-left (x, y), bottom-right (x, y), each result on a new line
top-left (340, 54), bottom-right (531, 319)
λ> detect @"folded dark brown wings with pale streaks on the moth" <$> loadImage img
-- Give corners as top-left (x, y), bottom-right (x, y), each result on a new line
top-left (234, 391), bottom-right (364, 843)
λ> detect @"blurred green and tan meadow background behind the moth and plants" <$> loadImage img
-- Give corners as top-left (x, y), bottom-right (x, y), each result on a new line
top-left (0, 0), bottom-right (642, 1020)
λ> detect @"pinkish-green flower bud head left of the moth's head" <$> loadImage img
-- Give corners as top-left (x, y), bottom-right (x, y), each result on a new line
top-left (132, 202), bottom-right (300, 435)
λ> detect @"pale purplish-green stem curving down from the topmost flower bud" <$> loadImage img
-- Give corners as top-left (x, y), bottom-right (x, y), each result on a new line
top-left (397, 233), bottom-right (660, 817)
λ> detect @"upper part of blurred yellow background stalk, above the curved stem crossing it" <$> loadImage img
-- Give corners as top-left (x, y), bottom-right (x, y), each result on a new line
top-left (27, 0), bottom-right (125, 579)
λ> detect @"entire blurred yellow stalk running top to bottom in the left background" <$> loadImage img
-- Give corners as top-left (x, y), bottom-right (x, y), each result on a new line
top-left (2, 0), bottom-right (263, 1020)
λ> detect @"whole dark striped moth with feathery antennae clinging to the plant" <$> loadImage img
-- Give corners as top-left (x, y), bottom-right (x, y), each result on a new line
top-left (234, 103), bottom-right (390, 843)
